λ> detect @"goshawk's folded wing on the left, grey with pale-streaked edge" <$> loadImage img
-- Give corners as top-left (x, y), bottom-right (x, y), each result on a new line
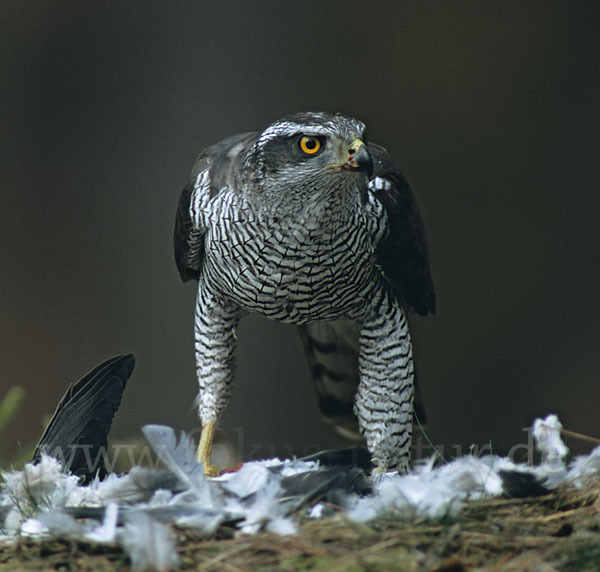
top-left (173, 133), bottom-right (257, 282)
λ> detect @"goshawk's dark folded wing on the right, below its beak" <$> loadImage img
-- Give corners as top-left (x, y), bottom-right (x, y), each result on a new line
top-left (368, 143), bottom-right (436, 316)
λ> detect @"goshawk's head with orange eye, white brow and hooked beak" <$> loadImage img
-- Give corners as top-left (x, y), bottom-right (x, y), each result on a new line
top-left (244, 112), bottom-right (373, 207)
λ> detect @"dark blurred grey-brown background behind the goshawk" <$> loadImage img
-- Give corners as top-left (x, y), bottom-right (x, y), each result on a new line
top-left (0, 0), bottom-right (600, 464)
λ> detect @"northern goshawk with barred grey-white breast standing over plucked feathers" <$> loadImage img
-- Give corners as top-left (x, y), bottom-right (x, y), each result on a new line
top-left (175, 113), bottom-right (435, 474)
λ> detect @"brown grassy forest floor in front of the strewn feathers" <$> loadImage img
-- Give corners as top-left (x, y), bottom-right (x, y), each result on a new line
top-left (0, 482), bottom-right (600, 572)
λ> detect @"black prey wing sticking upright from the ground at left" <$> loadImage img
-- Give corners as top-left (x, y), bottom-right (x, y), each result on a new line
top-left (32, 354), bottom-right (135, 483)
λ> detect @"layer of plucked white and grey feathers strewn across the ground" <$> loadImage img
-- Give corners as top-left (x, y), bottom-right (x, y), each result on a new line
top-left (0, 416), bottom-right (600, 560)
